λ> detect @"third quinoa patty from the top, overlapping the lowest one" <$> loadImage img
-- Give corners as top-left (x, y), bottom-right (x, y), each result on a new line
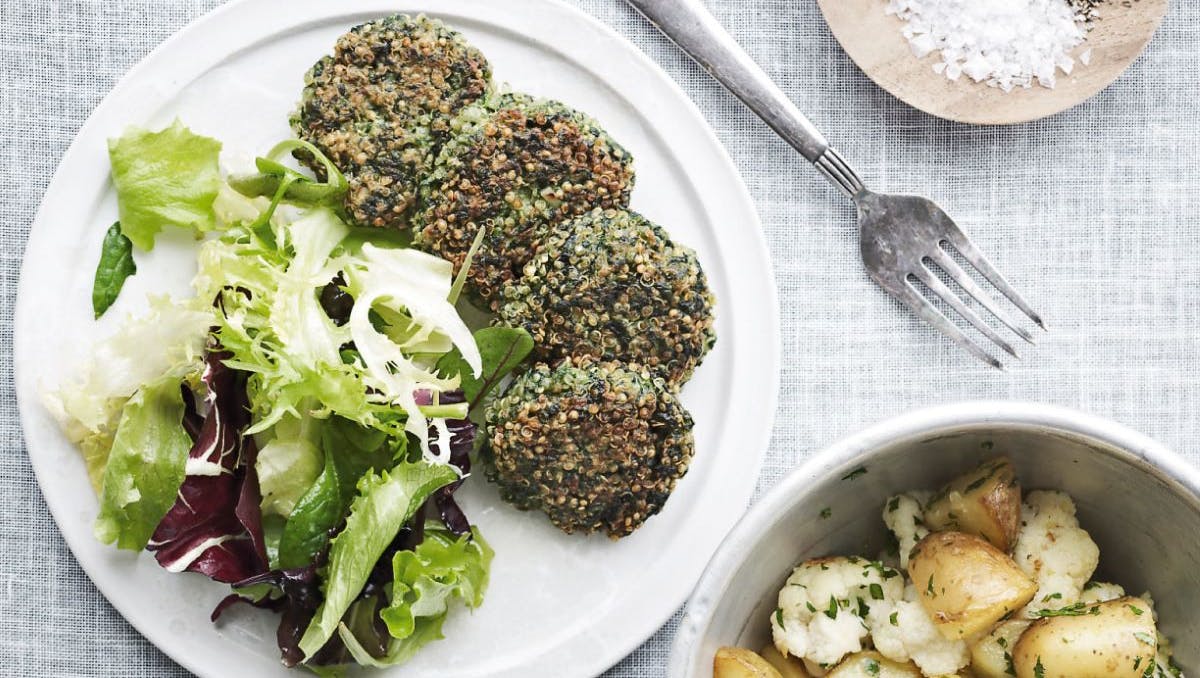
top-left (497, 210), bottom-right (716, 385)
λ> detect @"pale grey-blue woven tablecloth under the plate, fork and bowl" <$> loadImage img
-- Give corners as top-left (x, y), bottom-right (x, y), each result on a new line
top-left (0, 0), bottom-right (1200, 677)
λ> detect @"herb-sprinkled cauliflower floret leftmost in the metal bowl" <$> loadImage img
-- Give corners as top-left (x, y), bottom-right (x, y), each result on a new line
top-left (770, 557), bottom-right (904, 668)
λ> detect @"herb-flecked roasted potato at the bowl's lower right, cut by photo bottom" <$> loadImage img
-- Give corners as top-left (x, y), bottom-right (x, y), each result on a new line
top-left (1013, 598), bottom-right (1158, 678)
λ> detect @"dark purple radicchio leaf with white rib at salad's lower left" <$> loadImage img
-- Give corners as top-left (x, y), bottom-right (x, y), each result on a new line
top-left (146, 347), bottom-right (266, 583)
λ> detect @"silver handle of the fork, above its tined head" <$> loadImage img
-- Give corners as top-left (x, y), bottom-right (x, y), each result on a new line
top-left (628, 0), bottom-right (864, 198)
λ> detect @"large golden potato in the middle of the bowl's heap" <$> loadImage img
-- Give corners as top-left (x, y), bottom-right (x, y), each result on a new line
top-left (908, 532), bottom-right (1038, 641)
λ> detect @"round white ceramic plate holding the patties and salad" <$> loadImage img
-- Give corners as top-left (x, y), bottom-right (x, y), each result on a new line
top-left (16, 0), bottom-right (779, 678)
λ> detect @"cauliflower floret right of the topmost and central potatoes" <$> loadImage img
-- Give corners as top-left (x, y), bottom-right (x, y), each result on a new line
top-left (1013, 492), bottom-right (1100, 618)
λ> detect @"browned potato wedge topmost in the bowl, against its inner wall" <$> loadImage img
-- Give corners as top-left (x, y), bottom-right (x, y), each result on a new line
top-left (925, 457), bottom-right (1021, 553)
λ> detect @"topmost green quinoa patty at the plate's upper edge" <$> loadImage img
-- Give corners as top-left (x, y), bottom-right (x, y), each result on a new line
top-left (292, 14), bottom-right (492, 227)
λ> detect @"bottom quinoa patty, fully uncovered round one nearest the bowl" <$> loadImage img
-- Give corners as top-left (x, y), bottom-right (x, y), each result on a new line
top-left (487, 359), bottom-right (695, 539)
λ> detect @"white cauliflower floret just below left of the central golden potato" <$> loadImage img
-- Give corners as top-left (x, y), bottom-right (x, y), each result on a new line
top-left (866, 584), bottom-right (971, 676)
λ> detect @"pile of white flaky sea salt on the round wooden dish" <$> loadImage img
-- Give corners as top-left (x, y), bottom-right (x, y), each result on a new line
top-left (886, 0), bottom-right (1091, 91)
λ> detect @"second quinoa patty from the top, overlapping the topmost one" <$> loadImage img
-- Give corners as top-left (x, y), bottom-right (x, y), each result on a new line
top-left (415, 94), bottom-right (634, 311)
